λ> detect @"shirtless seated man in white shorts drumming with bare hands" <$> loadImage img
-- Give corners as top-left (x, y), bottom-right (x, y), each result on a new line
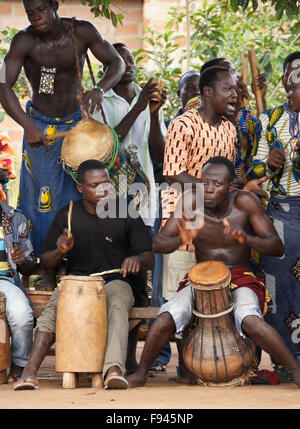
top-left (128, 157), bottom-right (300, 387)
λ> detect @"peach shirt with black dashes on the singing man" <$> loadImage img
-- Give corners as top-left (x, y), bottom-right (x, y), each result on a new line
top-left (162, 109), bottom-right (236, 250)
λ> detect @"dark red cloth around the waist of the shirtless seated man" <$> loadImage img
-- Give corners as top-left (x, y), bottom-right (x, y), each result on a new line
top-left (177, 268), bottom-right (272, 316)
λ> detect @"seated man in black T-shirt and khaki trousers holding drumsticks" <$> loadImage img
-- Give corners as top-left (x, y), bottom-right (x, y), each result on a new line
top-left (14, 160), bottom-right (154, 390)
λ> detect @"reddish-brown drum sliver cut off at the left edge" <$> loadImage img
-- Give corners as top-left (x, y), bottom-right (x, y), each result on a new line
top-left (0, 292), bottom-right (10, 384)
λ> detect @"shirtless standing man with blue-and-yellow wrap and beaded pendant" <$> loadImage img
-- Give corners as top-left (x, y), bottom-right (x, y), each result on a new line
top-left (0, 0), bottom-right (125, 286)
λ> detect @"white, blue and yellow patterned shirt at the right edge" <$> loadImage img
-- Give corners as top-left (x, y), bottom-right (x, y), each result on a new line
top-left (252, 103), bottom-right (300, 196)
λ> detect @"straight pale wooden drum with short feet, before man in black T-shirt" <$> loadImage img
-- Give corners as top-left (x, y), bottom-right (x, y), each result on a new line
top-left (55, 275), bottom-right (107, 388)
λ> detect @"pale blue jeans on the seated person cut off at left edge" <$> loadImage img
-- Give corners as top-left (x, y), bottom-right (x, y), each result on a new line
top-left (0, 279), bottom-right (33, 368)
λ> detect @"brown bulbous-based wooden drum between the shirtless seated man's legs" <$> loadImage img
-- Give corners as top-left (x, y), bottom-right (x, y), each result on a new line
top-left (183, 261), bottom-right (255, 385)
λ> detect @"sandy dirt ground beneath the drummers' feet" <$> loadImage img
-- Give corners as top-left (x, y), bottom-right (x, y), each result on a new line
top-left (0, 341), bottom-right (300, 415)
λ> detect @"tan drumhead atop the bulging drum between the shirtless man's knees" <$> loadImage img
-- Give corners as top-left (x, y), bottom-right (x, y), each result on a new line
top-left (189, 261), bottom-right (231, 287)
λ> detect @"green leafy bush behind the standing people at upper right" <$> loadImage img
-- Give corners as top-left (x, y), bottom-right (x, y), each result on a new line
top-left (137, 0), bottom-right (300, 116)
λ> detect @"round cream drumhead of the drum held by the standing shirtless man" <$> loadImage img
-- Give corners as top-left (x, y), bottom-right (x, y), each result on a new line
top-left (61, 118), bottom-right (114, 170)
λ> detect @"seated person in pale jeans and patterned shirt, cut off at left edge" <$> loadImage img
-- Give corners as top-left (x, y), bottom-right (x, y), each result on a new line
top-left (0, 187), bottom-right (36, 383)
